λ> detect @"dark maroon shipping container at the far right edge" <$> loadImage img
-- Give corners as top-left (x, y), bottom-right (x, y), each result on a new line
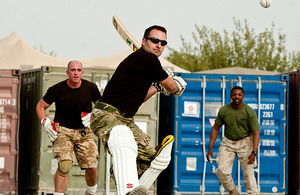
top-left (288, 70), bottom-right (300, 195)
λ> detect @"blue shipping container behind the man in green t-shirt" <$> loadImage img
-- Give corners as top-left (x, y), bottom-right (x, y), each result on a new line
top-left (157, 73), bottom-right (289, 195)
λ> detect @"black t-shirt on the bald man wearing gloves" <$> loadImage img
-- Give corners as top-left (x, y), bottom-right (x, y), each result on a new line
top-left (43, 79), bottom-right (101, 129)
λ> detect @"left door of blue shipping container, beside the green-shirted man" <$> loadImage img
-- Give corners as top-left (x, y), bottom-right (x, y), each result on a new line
top-left (174, 75), bottom-right (226, 194)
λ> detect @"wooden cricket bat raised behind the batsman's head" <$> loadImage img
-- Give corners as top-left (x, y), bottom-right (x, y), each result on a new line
top-left (113, 16), bottom-right (141, 51)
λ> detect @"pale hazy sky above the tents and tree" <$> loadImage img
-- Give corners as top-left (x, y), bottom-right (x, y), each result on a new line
top-left (0, 0), bottom-right (300, 59)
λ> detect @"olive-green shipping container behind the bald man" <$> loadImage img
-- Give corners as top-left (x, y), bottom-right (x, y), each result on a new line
top-left (19, 66), bottom-right (159, 195)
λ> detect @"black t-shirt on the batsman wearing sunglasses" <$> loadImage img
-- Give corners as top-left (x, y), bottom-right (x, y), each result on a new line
top-left (100, 48), bottom-right (168, 116)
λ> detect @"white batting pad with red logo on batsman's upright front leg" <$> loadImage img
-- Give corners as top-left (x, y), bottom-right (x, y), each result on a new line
top-left (107, 125), bottom-right (139, 195)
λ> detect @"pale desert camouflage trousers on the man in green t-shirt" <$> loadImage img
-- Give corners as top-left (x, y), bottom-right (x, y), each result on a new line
top-left (215, 135), bottom-right (258, 194)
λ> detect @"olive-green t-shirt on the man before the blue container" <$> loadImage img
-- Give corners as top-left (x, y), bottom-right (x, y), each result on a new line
top-left (215, 104), bottom-right (260, 141)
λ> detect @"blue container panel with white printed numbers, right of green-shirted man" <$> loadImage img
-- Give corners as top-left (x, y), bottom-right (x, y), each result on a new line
top-left (260, 83), bottom-right (287, 193)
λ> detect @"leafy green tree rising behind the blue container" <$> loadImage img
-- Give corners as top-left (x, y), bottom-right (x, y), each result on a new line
top-left (167, 18), bottom-right (300, 72)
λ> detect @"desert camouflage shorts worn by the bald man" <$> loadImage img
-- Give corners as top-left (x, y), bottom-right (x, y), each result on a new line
top-left (53, 126), bottom-right (99, 169)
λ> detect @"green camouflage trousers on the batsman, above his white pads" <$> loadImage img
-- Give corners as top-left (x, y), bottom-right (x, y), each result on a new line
top-left (91, 108), bottom-right (156, 175)
